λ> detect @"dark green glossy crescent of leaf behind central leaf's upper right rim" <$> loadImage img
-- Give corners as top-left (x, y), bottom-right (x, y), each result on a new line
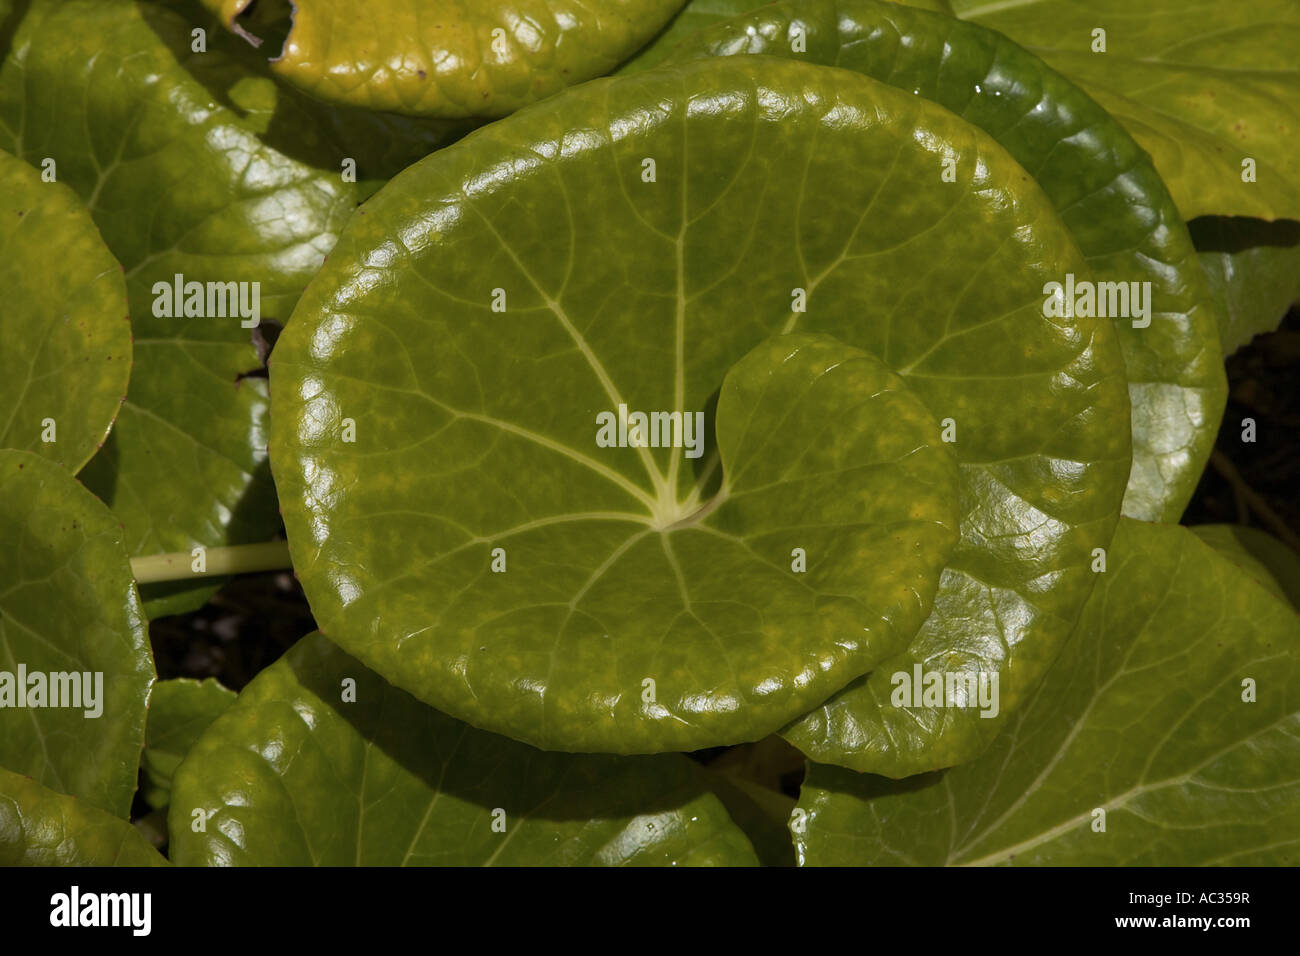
top-left (631, 0), bottom-right (1227, 522)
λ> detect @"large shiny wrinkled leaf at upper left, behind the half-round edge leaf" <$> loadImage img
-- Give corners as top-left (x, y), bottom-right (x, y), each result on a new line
top-left (0, 0), bottom-right (356, 617)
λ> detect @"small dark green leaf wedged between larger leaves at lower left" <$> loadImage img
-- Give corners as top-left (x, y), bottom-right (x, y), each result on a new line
top-left (142, 678), bottom-right (237, 809)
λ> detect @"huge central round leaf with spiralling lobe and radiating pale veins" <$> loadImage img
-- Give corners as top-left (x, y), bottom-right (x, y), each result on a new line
top-left (272, 57), bottom-right (1128, 752)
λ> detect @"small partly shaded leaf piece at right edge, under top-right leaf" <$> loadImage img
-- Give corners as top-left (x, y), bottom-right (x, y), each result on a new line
top-left (1190, 216), bottom-right (1300, 355)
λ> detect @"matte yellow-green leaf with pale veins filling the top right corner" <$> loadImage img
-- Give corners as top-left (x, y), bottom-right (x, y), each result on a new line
top-left (902, 0), bottom-right (1300, 220)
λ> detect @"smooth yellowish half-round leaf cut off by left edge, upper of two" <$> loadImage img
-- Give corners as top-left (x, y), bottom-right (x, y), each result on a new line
top-left (0, 152), bottom-right (131, 472)
